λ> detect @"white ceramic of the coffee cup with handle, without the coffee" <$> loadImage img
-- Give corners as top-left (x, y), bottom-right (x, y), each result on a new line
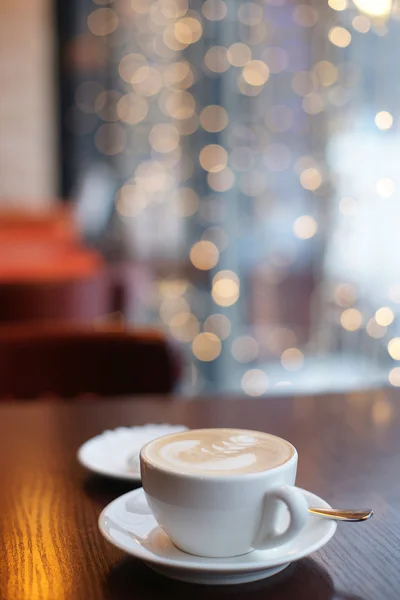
top-left (140, 429), bottom-right (308, 557)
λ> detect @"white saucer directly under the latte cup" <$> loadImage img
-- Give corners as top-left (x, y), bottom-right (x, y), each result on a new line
top-left (99, 488), bottom-right (336, 585)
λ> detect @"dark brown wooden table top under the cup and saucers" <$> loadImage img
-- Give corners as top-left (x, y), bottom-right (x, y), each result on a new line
top-left (0, 391), bottom-right (400, 600)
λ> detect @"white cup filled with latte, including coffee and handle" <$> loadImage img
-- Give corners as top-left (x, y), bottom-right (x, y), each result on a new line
top-left (140, 428), bottom-right (308, 557)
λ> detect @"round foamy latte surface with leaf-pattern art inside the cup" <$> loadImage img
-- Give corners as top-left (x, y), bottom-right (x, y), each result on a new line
top-left (143, 429), bottom-right (293, 475)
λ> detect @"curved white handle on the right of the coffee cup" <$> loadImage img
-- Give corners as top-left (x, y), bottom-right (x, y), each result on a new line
top-left (253, 485), bottom-right (308, 550)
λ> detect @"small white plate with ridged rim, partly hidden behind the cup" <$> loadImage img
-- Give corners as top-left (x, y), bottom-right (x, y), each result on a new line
top-left (77, 424), bottom-right (187, 481)
